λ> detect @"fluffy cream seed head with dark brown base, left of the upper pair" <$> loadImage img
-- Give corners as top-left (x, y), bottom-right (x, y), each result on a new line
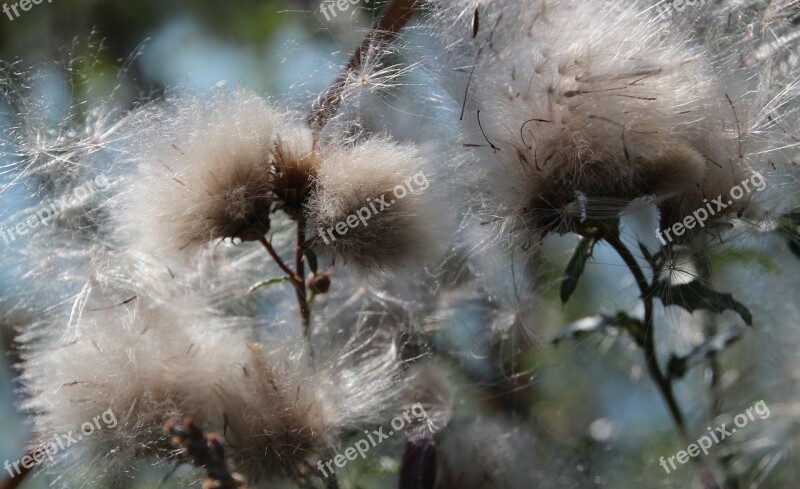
top-left (119, 92), bottom-right (317, 260)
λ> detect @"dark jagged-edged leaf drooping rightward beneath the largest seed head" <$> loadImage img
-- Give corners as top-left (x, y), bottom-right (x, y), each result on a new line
top-left (654, 280), bottom-right (753, 326)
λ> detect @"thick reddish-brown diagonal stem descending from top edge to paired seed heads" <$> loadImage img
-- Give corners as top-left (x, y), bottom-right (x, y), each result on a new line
top-left (308, 0), bottom-right (419, 132)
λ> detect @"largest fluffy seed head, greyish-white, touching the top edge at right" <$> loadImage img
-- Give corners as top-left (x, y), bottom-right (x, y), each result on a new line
top-left (428, 0), bottom-right (746, 242)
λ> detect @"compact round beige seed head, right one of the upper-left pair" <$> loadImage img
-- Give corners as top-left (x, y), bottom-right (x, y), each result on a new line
top-left (308, 137), bottom-right (434, 270)
